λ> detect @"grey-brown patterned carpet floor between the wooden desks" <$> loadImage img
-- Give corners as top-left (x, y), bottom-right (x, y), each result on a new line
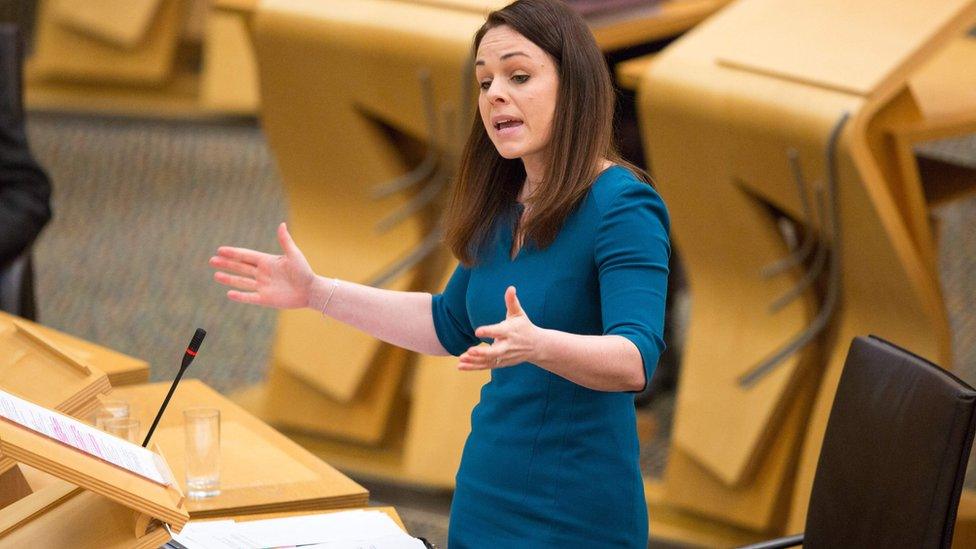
top-left (22, 114), bottom-right (976, 546)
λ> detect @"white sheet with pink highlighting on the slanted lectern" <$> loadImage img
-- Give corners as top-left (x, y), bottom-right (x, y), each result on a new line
top-left (0, 391), bottom-right (169, 485)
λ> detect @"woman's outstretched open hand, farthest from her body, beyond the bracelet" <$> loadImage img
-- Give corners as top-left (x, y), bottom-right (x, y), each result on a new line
top-left (210, 223), bottom-right (316, 309)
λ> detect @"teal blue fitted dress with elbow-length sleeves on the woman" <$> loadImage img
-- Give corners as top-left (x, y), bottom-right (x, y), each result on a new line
top-left (433, 166), bottom-right (670, 549)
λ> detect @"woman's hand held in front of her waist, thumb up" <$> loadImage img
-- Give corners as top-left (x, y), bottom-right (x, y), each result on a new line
top-left (458, 286), bottom-right (542, 370)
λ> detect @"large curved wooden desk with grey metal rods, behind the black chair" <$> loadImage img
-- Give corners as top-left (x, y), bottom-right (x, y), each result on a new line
top-left (638, 0), bottom-right (976, 537)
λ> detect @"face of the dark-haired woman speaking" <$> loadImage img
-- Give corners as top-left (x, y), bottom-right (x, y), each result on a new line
top-left (475, 25), bottom-right (559, 162)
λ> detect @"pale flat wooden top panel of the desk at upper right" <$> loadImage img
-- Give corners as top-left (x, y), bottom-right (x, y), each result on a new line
top-left (716, 0), bottom-right (972, 96)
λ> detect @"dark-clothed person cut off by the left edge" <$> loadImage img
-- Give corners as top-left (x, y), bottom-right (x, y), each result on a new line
top-left (0, 24), bottom-right (51, 320)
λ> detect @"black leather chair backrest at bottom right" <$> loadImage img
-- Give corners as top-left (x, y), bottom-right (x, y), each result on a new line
top-left (804, 336), bottom-right (976, 549)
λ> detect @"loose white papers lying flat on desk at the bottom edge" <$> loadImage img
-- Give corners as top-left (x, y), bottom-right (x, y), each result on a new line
top-left (173, 509), bottom-right (424, 549)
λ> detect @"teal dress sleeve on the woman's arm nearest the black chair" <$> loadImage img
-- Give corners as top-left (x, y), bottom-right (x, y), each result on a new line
top-left (595, 183), bottom-right (671, 388)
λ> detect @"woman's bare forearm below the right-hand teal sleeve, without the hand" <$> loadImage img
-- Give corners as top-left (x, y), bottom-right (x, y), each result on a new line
top-left (533, 328), bottom-right (644, 391)
